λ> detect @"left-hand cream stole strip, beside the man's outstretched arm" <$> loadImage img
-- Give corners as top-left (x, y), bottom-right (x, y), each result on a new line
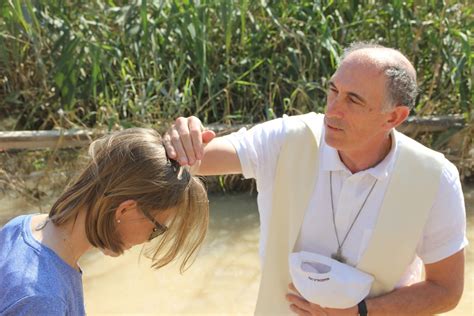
top-left (255, 113), bottom-right (323, 315)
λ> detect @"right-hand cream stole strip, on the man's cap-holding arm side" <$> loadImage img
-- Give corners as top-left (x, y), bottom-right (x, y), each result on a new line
top-left (357, 131), bottom-right (443, 297)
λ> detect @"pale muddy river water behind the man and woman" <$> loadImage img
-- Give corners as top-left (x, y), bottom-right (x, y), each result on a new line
top-left (0, 187), bottom-right (474, 315)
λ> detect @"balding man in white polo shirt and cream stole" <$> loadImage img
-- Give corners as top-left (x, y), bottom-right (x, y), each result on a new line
top-left (164, 43), bottom-right (467, 315)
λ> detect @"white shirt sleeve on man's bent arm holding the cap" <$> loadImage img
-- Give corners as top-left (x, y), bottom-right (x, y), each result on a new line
top-left (417, 160), bottom-right (468, 264)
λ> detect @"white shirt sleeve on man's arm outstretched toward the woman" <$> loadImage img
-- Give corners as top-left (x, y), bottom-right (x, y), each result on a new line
top-left (221, 118), bottom-right (284, 185)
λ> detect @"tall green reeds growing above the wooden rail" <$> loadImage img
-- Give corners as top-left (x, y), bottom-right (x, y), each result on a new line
top-left (0, 0), bottom-right (473, 129)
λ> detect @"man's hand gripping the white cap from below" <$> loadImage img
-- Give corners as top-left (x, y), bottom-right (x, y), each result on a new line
top-left (286, 283), bottom-right (359, 316)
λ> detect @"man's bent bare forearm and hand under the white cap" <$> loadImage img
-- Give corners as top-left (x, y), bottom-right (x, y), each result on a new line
top-left (287, 250), bottom-right (464, 316)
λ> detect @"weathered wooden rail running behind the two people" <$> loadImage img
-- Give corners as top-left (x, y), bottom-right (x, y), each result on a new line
top-left (0, 115), bottom-right (465, 151)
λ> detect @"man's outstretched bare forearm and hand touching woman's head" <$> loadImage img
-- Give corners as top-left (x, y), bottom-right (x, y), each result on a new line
top-left (163, 116), bottom-right (242, 175)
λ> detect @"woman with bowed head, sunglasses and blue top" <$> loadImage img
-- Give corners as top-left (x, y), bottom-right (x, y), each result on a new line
top-left (0, 128), bottom-right (209, 315)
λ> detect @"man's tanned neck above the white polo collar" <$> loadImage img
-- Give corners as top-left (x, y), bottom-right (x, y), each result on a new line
top-left (338, 134), bottom-right (392, 173)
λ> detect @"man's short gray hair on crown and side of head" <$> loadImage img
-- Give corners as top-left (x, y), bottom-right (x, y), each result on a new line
top-left (341, 42), bottom-right (418, 109)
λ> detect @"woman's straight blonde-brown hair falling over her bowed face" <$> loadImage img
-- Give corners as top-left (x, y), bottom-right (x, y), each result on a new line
top-left (49, 128), bottom-right (209, 272)
